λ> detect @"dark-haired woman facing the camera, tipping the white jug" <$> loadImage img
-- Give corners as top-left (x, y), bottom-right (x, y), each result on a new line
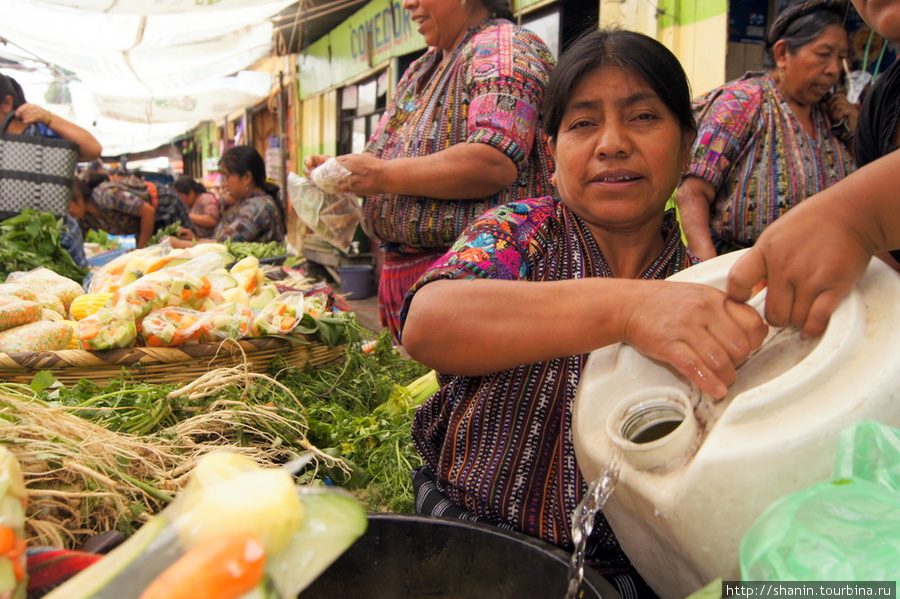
top-left (402, 30), bottom-right (766, 597)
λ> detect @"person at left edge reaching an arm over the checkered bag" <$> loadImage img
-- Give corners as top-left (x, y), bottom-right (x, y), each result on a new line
top-left (0, 74), bottom-right (103, 162)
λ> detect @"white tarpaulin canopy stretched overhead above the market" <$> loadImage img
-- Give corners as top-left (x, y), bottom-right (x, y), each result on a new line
top-left (0, 0), bottom-right (297, 155)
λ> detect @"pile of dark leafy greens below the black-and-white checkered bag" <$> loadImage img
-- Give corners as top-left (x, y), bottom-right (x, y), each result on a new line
top-left (0, 209), bottom-right (87, 283)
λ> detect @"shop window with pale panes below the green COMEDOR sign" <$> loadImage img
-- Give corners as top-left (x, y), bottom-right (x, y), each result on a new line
top-left (338, 71), bottom-right (388, 154)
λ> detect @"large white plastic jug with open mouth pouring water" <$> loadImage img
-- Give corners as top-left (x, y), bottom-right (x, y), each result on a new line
top-left (573, 252), bottom-right (900, 599)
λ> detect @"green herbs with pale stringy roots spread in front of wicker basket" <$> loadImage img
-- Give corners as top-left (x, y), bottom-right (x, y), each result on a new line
top-left (0, 332), bottom-right (437, 548)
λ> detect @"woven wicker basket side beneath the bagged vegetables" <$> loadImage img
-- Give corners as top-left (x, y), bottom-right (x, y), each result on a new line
top-left (0, 337), bottom-right (344, 386)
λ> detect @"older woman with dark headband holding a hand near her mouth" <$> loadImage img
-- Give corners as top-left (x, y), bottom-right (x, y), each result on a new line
top-left (676, 0), bottom-right (858, 260)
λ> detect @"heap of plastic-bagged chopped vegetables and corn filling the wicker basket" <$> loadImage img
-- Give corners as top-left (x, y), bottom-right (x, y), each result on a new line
top-left (0, 244), bottom-right (351, 353)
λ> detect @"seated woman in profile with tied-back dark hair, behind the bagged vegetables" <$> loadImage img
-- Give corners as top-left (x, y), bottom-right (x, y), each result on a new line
top-left (170, 146), bottom-right (286, 248)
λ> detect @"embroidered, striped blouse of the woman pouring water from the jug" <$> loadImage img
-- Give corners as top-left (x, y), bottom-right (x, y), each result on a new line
top-left (402, 197), bottom-right (694, 572)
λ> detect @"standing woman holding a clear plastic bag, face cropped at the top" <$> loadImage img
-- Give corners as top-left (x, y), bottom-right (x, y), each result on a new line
top-left (305, 0), bottom-right (554, 337)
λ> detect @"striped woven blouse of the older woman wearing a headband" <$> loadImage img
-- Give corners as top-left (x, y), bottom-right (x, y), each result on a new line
top-left (690, 74), bottom-right (855, 253)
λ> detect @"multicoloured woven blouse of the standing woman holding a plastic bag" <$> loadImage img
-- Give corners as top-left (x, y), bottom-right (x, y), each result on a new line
top-left (364, 19), bottom-right (554, 253)
